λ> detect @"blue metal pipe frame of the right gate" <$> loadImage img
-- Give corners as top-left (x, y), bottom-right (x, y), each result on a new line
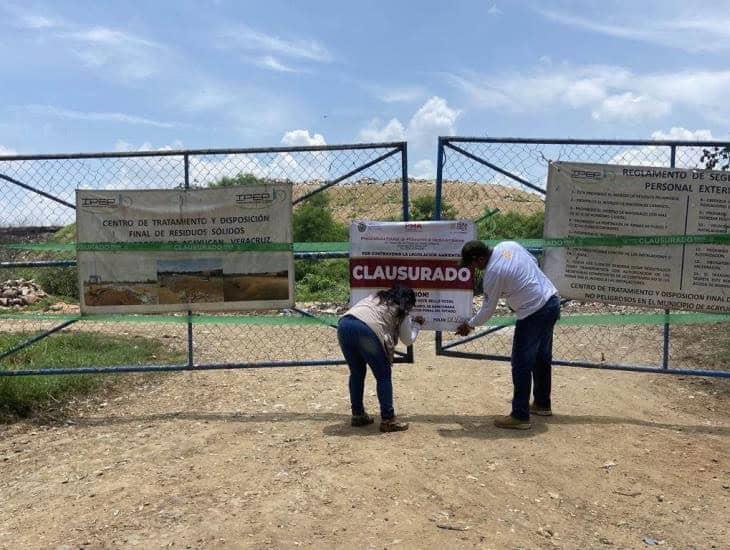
top-left (434, 136), bottom-right (730, 378)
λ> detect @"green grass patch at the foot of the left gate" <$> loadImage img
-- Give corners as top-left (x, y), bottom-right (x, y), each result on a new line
top-left (0, 332), bottom-right (183, 417)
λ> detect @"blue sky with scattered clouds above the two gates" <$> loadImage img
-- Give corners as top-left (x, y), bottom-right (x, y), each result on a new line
top-left (0, 0), bottom-right (730, 176)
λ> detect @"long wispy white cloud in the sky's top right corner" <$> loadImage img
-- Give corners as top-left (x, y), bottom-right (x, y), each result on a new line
top-left (538, 7), bottom-right (730, 52)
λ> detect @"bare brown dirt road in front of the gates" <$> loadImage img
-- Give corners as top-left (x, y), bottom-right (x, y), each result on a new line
top-left (0, 339), bottom-right (730, 549)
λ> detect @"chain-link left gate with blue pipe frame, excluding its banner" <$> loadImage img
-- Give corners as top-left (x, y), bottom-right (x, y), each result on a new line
top-left (0, 142), bottom-right (412, 376)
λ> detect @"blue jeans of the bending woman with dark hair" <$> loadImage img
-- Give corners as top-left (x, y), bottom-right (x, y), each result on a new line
top-left (337, 315), bottom-right (395, 420)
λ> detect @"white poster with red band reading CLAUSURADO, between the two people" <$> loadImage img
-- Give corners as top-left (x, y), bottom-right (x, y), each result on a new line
top-left (350, 220), bottom-right (476, 330)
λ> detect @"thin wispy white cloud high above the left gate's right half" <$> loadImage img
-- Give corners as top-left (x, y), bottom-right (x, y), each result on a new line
top-left (219, 25), bottom-right (332, 68)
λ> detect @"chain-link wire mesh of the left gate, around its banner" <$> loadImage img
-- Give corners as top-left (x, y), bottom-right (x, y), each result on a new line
top-left (0, 143), bottom-right (406, 376)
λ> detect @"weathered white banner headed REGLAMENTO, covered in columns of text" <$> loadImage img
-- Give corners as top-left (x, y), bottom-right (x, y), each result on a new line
top-left (544, 162), bottom-right (730, 313)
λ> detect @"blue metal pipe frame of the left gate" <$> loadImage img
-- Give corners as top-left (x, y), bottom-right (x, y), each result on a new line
top-left (0, 141), bottom-right (414, 377)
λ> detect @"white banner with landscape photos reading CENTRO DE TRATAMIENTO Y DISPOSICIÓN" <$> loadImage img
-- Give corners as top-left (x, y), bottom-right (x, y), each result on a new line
top-left (76, 187), bottom-right (294, 313)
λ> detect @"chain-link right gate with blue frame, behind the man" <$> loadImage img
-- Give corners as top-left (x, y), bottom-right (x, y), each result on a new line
top-left (436, 137), bottom-right (730, 376)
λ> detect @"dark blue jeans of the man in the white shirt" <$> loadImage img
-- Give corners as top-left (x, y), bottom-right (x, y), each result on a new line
top-left (512, 296), bottom-right (560, 420)
